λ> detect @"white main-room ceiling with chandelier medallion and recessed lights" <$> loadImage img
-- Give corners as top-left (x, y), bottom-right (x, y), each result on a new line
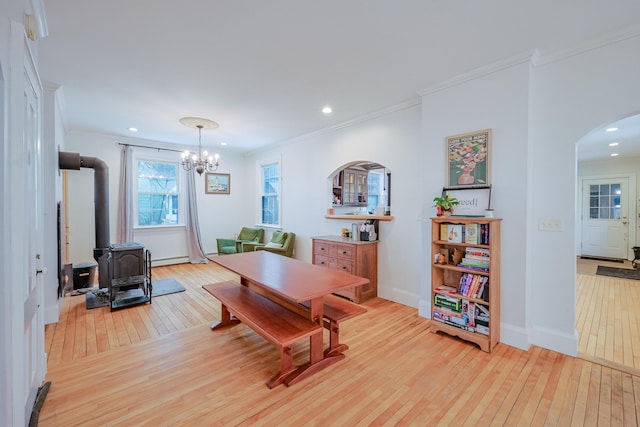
top-left (39, 0), bottom-right (640, 157)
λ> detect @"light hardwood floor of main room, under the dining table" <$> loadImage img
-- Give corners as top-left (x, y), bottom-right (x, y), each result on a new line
top-left (40, 264), bottom-right (640, 426)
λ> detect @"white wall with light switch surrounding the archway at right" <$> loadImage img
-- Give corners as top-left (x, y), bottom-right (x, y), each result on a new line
top-left (528, 35), bottom-right (640, 355)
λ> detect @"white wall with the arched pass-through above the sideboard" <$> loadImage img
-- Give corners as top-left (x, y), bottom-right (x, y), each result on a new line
top-left (246, 105), bottom-right (423, 307)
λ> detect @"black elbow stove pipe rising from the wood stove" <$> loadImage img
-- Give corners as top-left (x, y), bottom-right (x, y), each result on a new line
top-left (58, 151), bottom-right (110, 263)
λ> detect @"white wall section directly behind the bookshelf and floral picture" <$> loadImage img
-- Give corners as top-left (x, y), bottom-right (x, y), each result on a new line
top-left (420, 61), bottom-right (529, 348)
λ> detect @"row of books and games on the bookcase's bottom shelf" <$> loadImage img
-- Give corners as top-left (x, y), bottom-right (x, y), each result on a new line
top-left (432, 294), bottom-right (489, 335)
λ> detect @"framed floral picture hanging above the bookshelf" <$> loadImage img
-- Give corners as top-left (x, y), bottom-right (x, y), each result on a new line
top-left (446, 129), bottom-right (491, 188)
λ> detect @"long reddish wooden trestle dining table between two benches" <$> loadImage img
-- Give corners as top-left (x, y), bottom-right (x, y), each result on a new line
top-left (211, 251), bottom-right (369, 385)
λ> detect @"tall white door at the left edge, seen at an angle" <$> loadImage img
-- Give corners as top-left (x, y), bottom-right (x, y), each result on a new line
top-left (5, 22), bottom-right (46, 425)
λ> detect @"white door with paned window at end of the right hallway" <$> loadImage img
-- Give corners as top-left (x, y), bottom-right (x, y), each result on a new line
top-left (582, 178), bottom-right (629, 259)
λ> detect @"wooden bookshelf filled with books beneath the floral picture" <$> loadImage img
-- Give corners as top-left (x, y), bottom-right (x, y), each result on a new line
top-left (430, 217), bottom-right (502, 352)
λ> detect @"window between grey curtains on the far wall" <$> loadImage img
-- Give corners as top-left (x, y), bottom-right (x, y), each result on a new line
top-left (136, 160), bottom-right (180, 226)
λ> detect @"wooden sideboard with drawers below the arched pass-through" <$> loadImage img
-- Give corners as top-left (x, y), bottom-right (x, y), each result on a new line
top-left (312, 236), bottom-right (378, 304)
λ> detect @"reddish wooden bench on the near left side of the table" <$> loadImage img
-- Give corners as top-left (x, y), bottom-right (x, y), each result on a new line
top-left (203, 281), bottom-right (322, 388)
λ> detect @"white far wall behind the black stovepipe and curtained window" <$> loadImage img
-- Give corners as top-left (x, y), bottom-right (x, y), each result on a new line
top-left (65, 133), bottom-right (253, 265)
